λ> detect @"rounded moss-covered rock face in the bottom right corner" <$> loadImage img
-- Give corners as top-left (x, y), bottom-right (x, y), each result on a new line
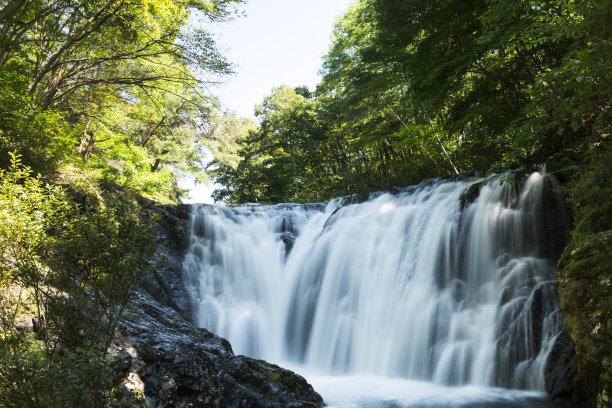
top-left (557, 230), bottom-right (612, 408)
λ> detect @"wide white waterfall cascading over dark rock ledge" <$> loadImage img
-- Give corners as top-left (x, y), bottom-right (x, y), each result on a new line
top-left (184, 173), bottom-right (565, 406)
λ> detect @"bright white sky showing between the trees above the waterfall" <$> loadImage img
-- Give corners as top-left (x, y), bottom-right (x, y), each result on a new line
top-left (181, 0), bottom-right (352, 203)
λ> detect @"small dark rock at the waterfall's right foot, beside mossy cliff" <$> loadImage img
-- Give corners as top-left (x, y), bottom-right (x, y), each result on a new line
top-left (544, 329), bottom-right (578, 402)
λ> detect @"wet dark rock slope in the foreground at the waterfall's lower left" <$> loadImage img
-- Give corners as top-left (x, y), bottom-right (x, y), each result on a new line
top-left (114, 293), bottom-right (323, 408)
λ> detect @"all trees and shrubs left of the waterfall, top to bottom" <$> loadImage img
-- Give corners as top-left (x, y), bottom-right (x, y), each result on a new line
top-left (0, 0), bottom-right (242, 408)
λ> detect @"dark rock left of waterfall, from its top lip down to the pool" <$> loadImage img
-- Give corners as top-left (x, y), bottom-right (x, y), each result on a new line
top-left (111, 201), bottom-right (323, 408)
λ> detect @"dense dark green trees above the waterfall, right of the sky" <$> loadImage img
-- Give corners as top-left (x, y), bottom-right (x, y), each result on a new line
top-left (212, 0), bottom-right (612, 203)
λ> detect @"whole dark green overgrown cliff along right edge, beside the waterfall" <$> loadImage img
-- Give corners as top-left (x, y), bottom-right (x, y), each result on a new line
top-left (557, 142), bottom-right (612, 408)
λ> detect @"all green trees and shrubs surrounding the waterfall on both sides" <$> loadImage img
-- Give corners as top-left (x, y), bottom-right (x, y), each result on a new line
top-left (0, 0), bottom-right (612, 407)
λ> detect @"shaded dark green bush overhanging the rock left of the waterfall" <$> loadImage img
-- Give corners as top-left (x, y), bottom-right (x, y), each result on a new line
top-left (41, 196), bottom-right (156, 354)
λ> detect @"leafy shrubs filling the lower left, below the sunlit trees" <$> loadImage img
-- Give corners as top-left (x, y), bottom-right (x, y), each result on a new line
top-left (0, 155), bottom-right (157, 407)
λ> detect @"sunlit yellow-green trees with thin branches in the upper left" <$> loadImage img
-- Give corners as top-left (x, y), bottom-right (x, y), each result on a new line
top-left (0, 0), bottom-right (242, 202)
